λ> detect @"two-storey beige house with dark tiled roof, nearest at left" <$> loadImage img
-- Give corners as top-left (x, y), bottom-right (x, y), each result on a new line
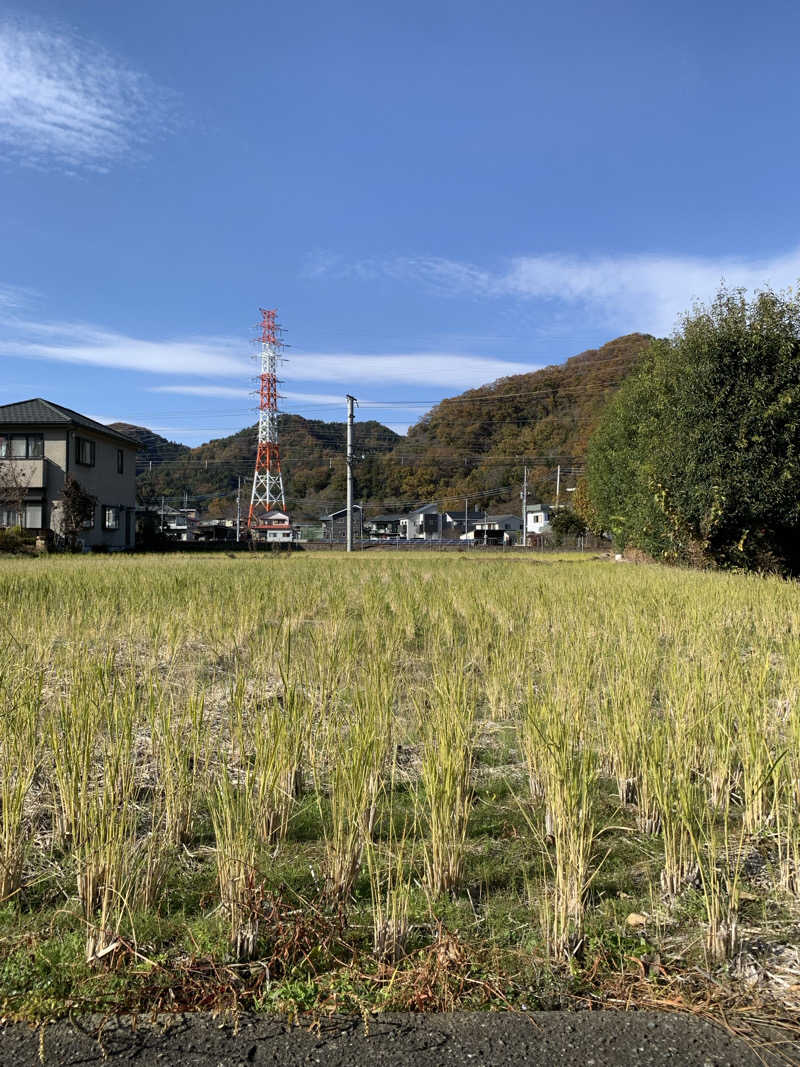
top-left (0, 397), bottom-right (138, 548)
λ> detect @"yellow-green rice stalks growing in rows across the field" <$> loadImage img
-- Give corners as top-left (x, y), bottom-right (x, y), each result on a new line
top-left (0, 552), bottom-right (800, 985)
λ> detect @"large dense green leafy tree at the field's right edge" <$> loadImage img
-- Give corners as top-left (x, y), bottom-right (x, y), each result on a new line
top-left (587, 288), bottom-right (800, 573)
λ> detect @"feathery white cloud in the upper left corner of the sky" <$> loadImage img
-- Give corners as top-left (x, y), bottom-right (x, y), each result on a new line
top-left (0, 19), bottom-right (174, 170)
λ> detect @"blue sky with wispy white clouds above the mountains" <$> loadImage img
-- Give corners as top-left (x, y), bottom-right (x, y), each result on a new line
top-left (0, 0), bottom-right (800, 444)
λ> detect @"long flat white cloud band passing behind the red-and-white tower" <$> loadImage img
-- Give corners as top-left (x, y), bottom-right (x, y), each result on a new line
top-left (0, 315), bottom-right (537, 390)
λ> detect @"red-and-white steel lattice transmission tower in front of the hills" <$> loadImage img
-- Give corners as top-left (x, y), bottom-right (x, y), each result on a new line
top-left (247, 307), bottom-right (286, 530)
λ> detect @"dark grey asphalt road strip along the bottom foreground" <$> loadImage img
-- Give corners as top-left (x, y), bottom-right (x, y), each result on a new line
top-left (0, 1012), bottom-right (800, 1067)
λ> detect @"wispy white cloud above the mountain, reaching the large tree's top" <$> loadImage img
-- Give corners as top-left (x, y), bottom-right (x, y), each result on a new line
top-left (307, 249), bottom-right (800, 334)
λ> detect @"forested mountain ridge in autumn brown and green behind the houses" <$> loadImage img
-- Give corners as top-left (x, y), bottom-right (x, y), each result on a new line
top-left (123, 334), bottom-right (652, 519)
